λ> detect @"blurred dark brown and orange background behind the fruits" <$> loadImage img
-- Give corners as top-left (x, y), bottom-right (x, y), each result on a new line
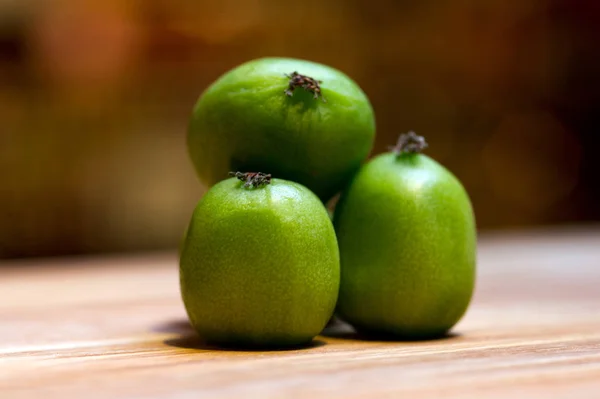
top-left (0, 0), bottom-right (600, 258)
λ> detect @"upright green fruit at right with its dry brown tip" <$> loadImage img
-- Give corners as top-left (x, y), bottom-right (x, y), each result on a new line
top-left (334, 132), bottom-right (476, 339)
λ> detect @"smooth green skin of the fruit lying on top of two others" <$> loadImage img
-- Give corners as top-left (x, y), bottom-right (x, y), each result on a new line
top-left (187, 58), bottom-right (375, 202)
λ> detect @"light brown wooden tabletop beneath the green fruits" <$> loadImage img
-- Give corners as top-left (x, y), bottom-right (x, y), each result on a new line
top-left (0, 228), bottom-right (600, 399)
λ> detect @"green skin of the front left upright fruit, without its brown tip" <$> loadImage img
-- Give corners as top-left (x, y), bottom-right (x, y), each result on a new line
top-left (180, 178), bottom-right (340, 347)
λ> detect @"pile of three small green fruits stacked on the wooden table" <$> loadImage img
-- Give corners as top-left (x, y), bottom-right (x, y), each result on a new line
top-left (180, 58), bottom-right (476, 347)
